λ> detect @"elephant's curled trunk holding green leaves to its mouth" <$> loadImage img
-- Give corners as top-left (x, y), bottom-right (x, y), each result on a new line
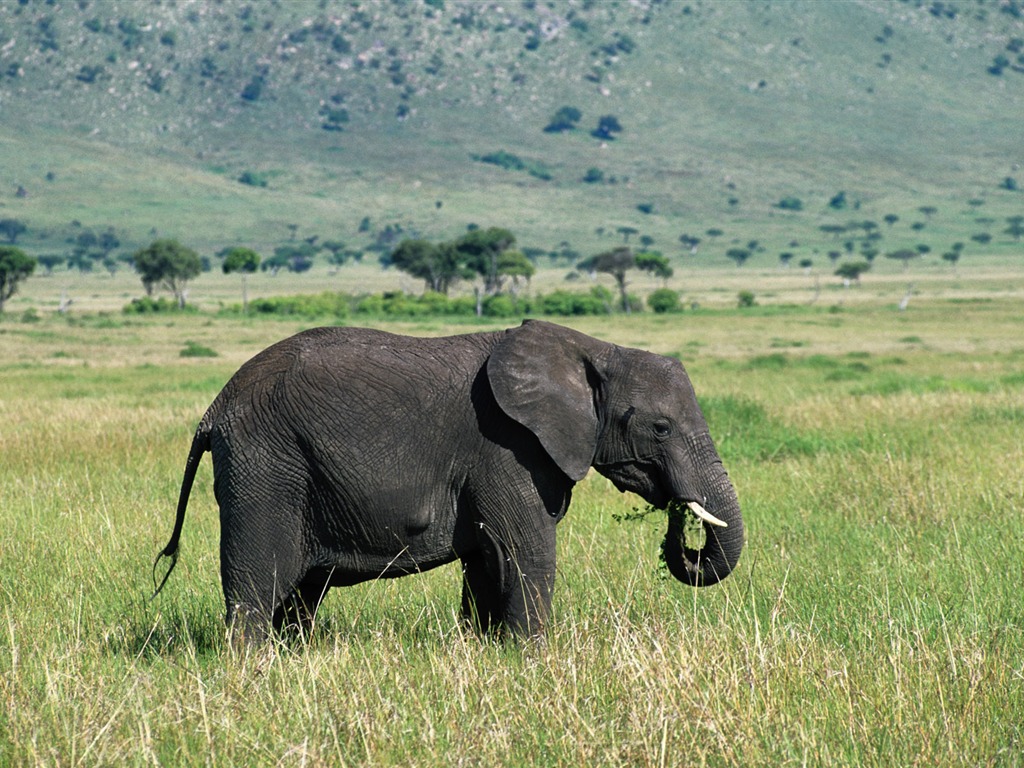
top-left (662, 442), bottom-right (743, 587)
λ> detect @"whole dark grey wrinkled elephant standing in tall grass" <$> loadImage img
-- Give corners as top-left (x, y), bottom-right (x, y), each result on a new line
top-left (155, 322), bottom-right (743, 641)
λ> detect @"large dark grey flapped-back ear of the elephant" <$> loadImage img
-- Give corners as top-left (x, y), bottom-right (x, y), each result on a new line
top-left (487, 321), bottom-right (608, 480)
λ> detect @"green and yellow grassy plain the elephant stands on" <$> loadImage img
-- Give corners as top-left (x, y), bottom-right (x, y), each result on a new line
top-left (0, 270), bottom-right (1024, 766)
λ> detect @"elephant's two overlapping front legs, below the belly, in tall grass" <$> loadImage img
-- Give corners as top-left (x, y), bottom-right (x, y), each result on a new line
top-left (462, 520), bottom-right (555, 637)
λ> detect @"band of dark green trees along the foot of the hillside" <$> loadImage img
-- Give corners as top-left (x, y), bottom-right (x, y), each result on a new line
top-left (0, 189), bottom-right (1024, 314)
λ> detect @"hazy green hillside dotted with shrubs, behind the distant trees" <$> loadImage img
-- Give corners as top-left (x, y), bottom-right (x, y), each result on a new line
top-left (0, 0), bottom-right (1024, 258)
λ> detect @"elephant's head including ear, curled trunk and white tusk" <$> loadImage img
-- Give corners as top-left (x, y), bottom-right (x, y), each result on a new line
top-left (487, 321), bottom-right (743, 587)
